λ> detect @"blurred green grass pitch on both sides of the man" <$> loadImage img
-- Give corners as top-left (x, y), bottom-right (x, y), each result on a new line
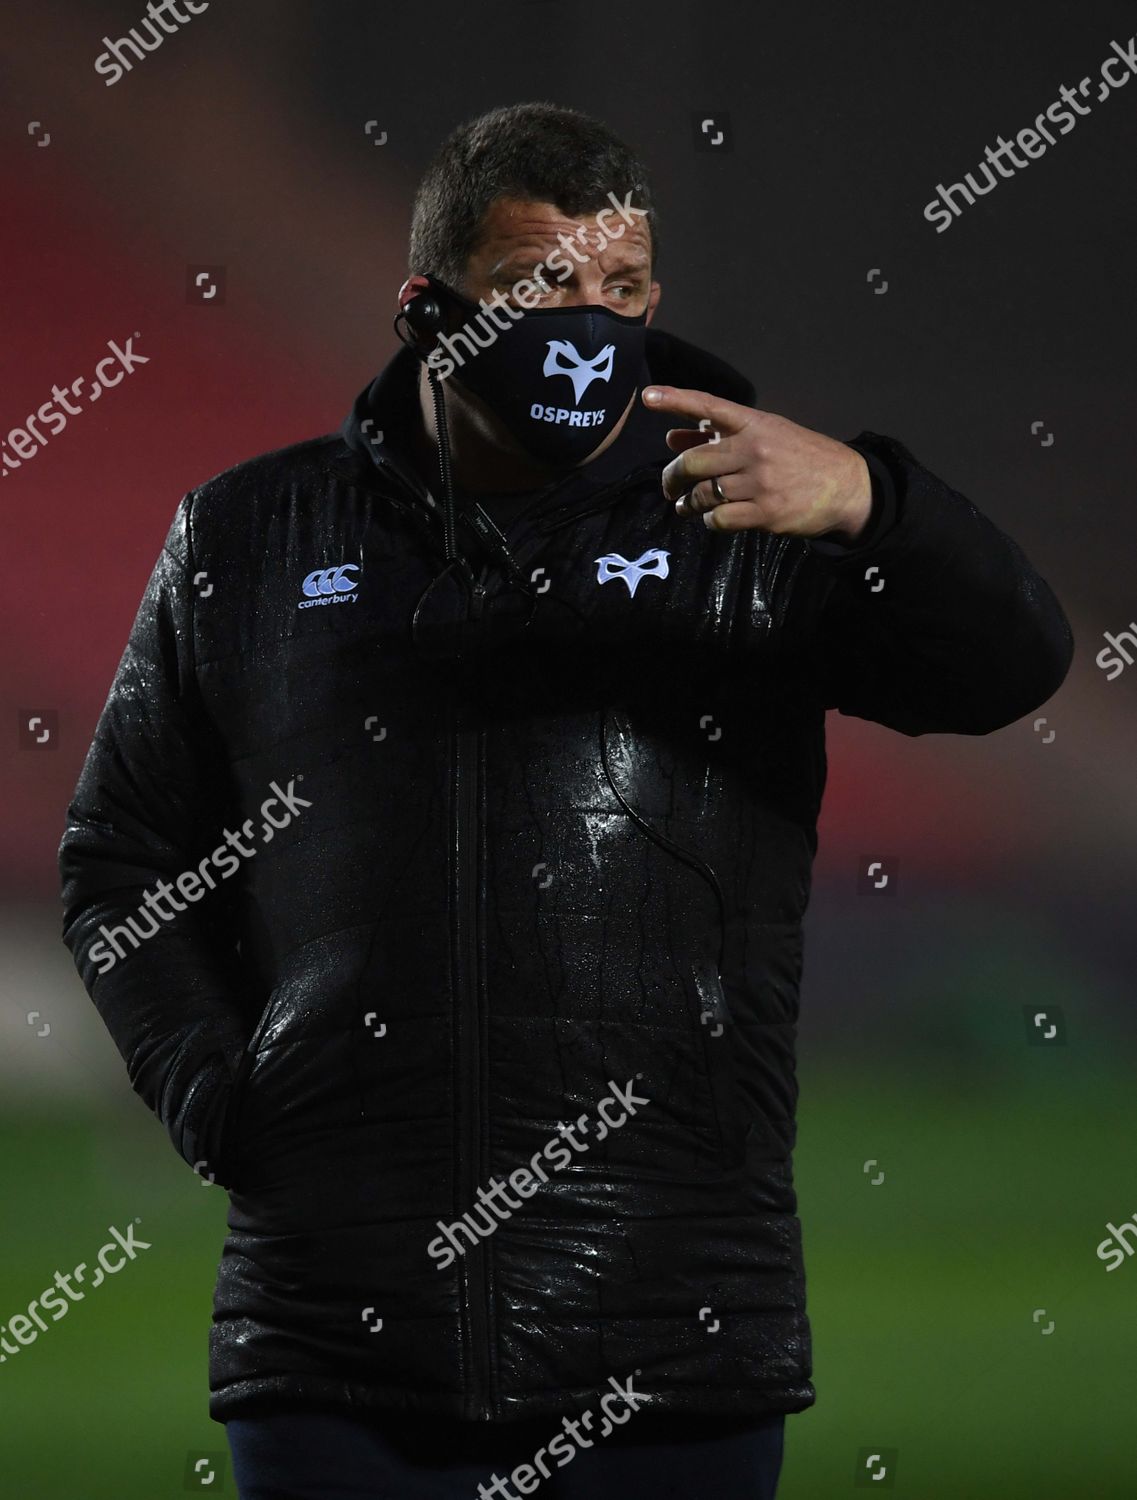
top-left (0, 1064), bottom-right (1137, 1500)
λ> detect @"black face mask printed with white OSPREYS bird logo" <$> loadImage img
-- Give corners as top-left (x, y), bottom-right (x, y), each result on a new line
top-left (426, 276), bottom-right (648, 468)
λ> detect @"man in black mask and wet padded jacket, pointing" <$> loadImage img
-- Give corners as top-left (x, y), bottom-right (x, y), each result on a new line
top-left (60, 96), bottom-right (1073, 1500)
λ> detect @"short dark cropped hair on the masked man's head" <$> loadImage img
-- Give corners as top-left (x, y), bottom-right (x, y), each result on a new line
top-left (408, 104), bottom-right (660, 287)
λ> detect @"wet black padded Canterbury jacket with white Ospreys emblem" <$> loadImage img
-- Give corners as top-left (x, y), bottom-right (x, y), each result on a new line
top-left (60, 330), bottom-right (1073, 1421)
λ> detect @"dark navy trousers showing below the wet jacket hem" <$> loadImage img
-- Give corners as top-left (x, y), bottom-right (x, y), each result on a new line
top-left (225, 1410), bottom-right (785, 1500)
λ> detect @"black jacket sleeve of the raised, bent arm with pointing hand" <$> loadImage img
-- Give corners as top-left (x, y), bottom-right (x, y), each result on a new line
top-left (786, 432), bottom-right (1074, 735)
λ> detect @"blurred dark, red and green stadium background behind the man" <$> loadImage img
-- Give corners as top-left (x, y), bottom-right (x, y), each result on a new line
top-left (0, 0), bottom-right (1137, 1500)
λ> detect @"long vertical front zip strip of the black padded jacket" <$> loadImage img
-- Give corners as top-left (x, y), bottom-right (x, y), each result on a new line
top-left (455, 570), bottom-right (492, 1422)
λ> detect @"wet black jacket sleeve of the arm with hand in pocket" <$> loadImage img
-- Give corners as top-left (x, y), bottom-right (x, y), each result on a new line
top-left (59, 497), bottom-right (245, 1181)
